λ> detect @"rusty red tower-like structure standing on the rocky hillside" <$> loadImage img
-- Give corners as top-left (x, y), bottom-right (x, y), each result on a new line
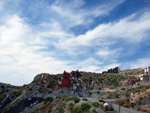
top-left (61, 71), bottom-right (71, 87)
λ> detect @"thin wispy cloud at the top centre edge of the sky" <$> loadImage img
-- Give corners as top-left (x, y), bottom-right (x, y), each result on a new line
top-left (51, 0), bottom-right (125, 27)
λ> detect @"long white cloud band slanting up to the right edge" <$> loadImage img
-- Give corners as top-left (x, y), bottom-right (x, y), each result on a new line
top-left (59, 12), bottom-right (150, 50)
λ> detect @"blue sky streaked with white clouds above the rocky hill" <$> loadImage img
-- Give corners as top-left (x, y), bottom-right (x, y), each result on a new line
top-left (0, 0), bottom-right (150, 85)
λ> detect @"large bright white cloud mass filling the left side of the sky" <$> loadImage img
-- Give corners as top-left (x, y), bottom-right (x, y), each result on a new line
top-left (0, 15), bottom-right (74, 85)
